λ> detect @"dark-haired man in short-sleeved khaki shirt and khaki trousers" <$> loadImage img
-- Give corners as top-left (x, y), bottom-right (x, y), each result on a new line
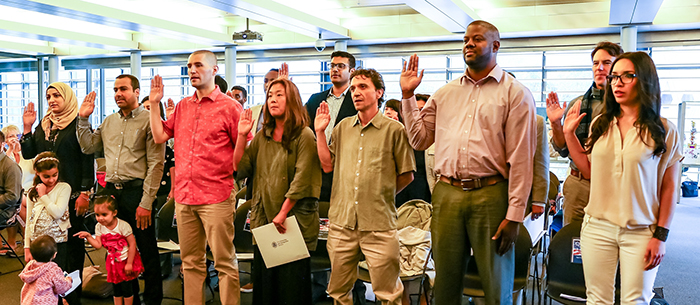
top-left (314, 69), bottom-right (416, 305)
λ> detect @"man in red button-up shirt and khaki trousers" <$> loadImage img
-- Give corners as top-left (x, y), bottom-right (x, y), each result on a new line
top-left (150, 50), bottom-right (243, 305)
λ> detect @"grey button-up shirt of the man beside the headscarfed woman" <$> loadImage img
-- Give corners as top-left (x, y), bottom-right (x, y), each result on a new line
top-left (77, 106), bottom-right (165, 210)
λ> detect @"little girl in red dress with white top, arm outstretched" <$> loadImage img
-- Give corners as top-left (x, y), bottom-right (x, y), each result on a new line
top-left (75, 196), bottom-right (143, 305)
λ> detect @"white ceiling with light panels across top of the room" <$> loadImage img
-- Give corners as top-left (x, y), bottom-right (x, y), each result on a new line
top-left (0, 0), bottom-right (700, 56)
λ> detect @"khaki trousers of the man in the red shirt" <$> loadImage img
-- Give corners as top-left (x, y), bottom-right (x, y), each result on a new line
top-left (175, 194), bottom-right (241, 305)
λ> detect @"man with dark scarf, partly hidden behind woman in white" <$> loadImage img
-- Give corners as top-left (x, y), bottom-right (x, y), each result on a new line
top-left (547, 41), bottom-right (624, 225)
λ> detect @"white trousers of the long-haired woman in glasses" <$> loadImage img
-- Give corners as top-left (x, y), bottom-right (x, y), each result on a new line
top-left (581, 215), bottom-right (659, 305)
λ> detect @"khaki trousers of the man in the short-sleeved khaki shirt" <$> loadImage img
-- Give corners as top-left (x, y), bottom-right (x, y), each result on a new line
top-left (328, 224), bottom-right (403, 305)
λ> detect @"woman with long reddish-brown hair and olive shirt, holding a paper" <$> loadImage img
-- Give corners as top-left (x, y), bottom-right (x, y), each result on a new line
top-left (234, 79), bottom-right (321, 305)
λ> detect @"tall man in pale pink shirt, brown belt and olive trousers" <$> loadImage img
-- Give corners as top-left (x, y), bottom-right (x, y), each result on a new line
top-left (400, 20), bottom-right (536, 305)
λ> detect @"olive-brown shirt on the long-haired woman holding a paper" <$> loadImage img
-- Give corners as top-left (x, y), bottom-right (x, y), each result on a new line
top-left (236, 127), bottom-right (321, 251)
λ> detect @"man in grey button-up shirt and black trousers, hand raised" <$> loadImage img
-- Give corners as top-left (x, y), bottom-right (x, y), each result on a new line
top-left (77, 74), bottom-right (165, 305)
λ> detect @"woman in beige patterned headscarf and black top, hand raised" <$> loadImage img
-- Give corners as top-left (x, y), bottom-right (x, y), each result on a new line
top-left (20, 82), bottom-right (95, 305)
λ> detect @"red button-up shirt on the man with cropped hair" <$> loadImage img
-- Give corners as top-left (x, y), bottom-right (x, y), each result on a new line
top-left (163, 86), bottom-right (251, 205)
